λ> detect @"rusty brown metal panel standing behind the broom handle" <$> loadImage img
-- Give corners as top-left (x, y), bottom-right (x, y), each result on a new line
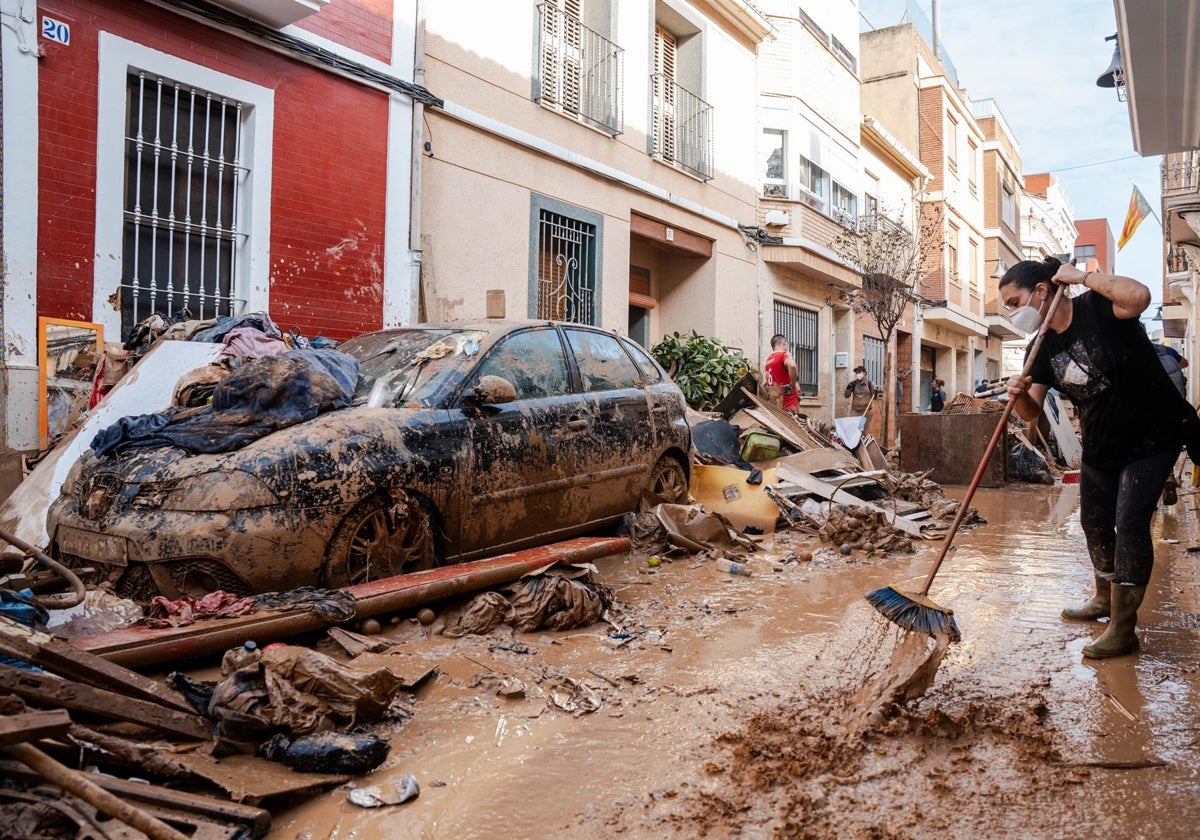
top-left (900, 412), bottom-right (1008, 487)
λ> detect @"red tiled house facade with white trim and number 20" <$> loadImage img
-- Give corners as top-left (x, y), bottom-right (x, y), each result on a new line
top-left (0, 0), bottom-right (432, 484)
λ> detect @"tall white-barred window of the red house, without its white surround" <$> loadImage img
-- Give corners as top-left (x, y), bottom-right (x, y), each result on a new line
top-left (121, 72), bottom-right (250, 334)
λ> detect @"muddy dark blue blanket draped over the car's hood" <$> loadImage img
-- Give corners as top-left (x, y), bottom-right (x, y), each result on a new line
top-left (91, 349), bottom-right (359, 457)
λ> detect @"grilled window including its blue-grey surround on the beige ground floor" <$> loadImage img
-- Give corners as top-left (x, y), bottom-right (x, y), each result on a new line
top-left (530, 196), bottom-right (600, 325)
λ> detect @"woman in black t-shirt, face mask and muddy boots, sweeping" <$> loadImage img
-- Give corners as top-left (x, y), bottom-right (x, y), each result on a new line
top-left (1000, 257), bottom-right (1188, 659)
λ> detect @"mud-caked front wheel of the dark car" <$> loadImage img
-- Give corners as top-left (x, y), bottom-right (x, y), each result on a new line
top-left (323, 494), bottom-right (437, 587)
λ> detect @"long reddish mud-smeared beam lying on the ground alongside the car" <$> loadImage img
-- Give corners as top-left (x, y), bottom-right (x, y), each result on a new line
top-left (71, 538), bottom-right (629, 667)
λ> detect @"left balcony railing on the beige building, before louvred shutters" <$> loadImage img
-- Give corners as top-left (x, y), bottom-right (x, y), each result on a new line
top-left (534, 4), bottom-right (624, 134)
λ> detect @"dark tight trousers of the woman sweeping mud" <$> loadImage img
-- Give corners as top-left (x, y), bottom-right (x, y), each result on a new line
top-left (1079, 452), bottom-right (1178, 586)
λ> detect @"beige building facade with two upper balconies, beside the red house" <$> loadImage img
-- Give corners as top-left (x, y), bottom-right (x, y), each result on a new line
top-left (416, 0), bottom-right (770, 359)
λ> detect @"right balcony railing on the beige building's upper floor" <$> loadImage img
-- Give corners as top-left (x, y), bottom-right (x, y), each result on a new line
top-left (650, 73), bottom-right (713, 181)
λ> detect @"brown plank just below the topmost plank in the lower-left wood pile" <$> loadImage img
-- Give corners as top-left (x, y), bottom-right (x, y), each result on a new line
top-left (0, 665), bottom-right (212, 740)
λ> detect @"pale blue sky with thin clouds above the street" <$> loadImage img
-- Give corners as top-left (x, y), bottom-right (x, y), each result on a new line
top-left (859, 0), bottom-right (1163, 316)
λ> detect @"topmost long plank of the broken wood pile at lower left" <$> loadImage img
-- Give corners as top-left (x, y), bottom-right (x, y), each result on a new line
top-left (0, 616), bottom-right (193, 713)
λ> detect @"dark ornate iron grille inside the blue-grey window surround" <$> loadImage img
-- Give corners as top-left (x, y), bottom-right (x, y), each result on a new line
top-left (538, 210), bottom-right (596, 324)
